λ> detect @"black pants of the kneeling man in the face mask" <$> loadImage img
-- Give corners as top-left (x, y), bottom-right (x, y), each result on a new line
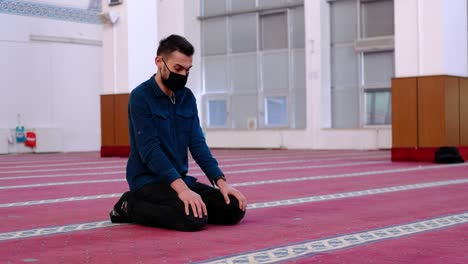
top-left (128, 182), bottom-right (245, 231)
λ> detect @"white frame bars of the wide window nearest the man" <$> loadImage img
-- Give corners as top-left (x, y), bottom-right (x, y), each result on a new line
top-left (199, 0), bottom-right (306, 130)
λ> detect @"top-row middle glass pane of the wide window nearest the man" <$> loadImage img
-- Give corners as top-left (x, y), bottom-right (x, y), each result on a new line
top-left (231, 14), bottom-right (257, 52)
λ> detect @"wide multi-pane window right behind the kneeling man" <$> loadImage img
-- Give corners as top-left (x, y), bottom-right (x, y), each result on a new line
top-left (200, 0), bottom-right (306, 130)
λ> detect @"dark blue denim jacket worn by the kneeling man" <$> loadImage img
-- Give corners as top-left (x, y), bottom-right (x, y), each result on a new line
top-left (127, 75), bottom-right (223, 191)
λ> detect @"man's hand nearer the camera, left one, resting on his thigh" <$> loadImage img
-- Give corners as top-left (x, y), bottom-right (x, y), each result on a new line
top-left (171, 179), bottom-right (208, 218)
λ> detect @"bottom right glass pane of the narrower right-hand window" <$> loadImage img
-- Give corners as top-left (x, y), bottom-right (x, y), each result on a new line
top-left (365, 90), bottom-right (392, 125)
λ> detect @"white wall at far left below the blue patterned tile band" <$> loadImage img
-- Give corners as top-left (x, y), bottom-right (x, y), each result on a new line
top-left (0, 14), bottom-right (102, 151)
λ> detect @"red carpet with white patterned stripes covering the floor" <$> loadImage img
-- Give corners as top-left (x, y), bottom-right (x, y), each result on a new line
top-left (0, 150), bottom-right (468, 264)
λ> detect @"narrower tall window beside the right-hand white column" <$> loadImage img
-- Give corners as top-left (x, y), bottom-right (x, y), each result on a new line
top-left (330, 0), bottom-right (395, 128)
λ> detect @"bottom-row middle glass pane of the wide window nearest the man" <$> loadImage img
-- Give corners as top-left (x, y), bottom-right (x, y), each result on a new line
top-left (231, 95), bottom-right (257, 129)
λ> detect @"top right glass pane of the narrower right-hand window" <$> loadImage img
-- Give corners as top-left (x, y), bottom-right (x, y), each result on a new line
top-left (361, 0), bottom-right (394, 38)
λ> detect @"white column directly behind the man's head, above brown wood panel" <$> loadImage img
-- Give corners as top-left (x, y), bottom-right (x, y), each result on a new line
top-left (102, 0), bottom-right (158, 94)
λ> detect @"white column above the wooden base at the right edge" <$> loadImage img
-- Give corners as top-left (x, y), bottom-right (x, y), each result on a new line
top-left (395, 0), bottom-right (468, 77)
